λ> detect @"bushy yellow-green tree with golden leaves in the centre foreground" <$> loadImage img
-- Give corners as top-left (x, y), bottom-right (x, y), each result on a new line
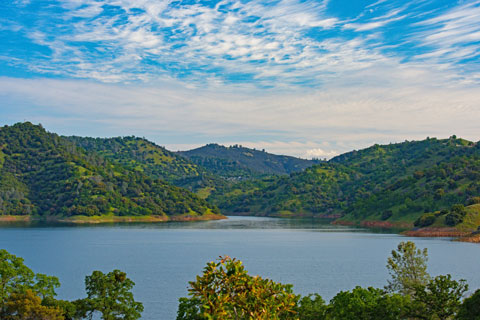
top-left (177, 256), bottom-right (298, 320)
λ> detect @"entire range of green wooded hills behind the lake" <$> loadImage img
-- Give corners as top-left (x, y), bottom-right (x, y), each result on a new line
top-left (0, 123), bottom-right (480, 231)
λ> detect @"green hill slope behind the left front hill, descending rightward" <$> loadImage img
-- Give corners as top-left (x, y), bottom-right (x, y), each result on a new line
top-left (66, 136), bottom-right (226, 197)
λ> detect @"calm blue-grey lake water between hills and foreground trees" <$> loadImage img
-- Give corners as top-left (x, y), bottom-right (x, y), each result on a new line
top-left (0, 217), bottom-right (480, 320)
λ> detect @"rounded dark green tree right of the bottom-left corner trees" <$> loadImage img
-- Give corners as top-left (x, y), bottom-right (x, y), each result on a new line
top-left (82, 270), bottom-right (143, 320)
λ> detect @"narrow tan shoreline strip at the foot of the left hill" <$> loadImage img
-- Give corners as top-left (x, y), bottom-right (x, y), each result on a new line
top-left (0, 214), bottom-right (227, 224)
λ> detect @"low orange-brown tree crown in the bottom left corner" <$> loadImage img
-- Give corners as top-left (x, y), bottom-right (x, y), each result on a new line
top-left (2, 289), bottom-right (64, 320)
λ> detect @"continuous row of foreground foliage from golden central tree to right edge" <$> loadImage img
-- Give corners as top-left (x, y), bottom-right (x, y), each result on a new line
top-left (177, 252), bottom-right (480, 320)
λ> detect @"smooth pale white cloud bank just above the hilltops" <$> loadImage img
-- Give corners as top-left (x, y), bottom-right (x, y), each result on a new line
top-left (0, 70), bottom-right (480, 157)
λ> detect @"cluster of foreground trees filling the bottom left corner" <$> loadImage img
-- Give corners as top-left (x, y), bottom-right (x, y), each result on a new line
top-left (0, 250), bottom-right (143, 320)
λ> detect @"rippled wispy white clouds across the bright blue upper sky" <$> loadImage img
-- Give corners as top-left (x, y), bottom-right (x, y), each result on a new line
top-left (1, 0), bottom-right (480, 87)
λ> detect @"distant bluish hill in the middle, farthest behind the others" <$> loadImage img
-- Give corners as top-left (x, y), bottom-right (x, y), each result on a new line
top-left (179, 143), bottom-right (318, 180)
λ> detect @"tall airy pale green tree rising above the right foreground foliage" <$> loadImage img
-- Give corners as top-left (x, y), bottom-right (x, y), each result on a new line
top-left (385, 241), bottom-right (430, 295)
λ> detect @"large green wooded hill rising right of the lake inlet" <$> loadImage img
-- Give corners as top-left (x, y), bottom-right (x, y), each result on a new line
top-left (213, 137), bottom-right (480, 228)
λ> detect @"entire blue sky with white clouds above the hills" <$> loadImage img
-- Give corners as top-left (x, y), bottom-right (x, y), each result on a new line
top-left (0, 0), bottom-right (480, 158)
